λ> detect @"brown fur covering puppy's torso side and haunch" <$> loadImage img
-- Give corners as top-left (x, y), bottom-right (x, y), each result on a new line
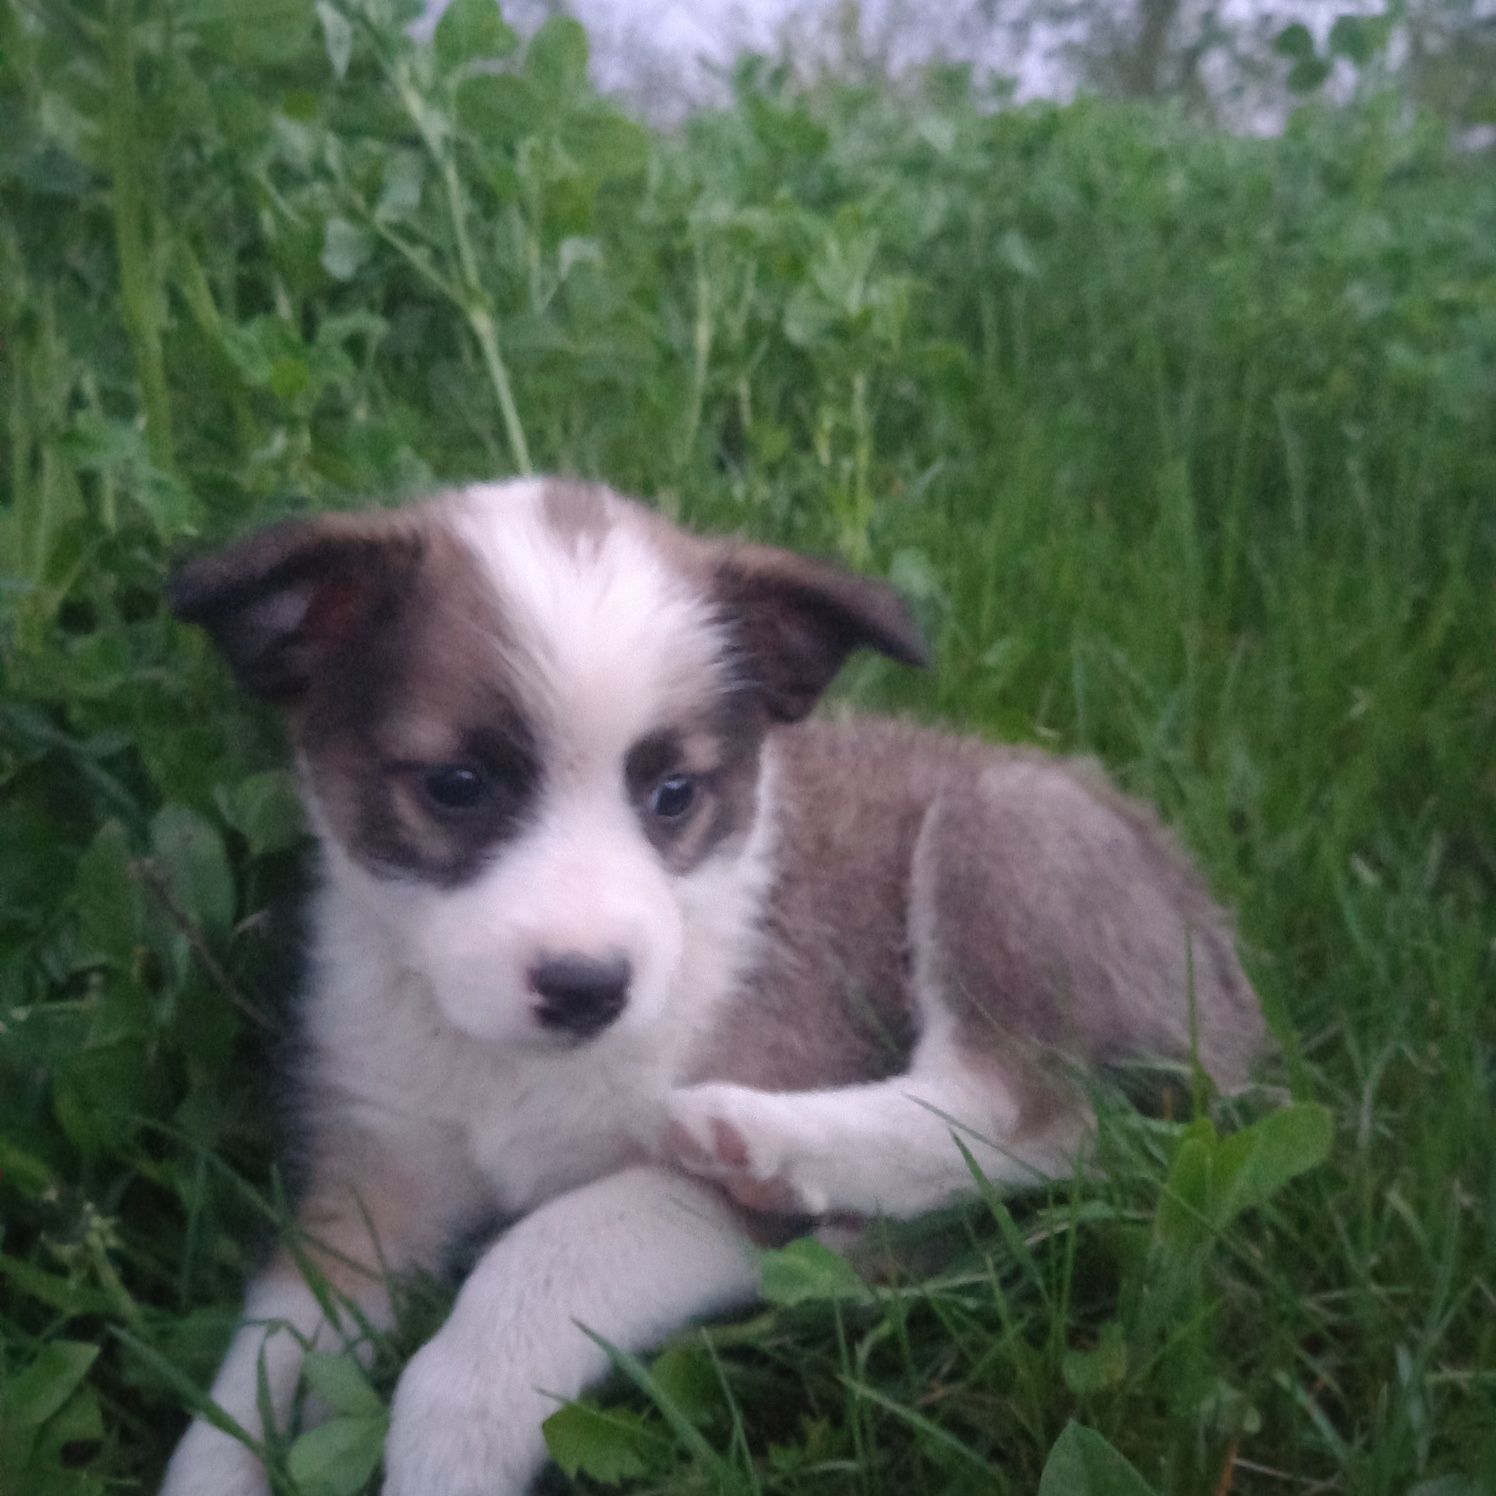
top-left (693, 721), bottom-right (1264, 1107)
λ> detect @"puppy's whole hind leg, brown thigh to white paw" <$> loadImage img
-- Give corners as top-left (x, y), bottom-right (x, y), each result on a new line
top-left (667, 754), bottom-right (1261, 1216)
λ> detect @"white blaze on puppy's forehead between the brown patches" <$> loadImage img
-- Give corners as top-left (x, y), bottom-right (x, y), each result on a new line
top-left (455, 480), bottom-right (723, 763)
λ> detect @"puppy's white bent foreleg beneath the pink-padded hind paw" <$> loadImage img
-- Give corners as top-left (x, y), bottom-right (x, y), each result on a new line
top-left (384, 1165), bottom-right (758, 1496)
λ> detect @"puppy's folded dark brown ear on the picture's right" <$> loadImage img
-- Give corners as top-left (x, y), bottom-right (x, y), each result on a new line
top-left (715, 545), bottom-right (929, 723)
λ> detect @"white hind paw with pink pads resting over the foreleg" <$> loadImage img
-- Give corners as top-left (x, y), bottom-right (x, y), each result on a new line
top-left (664, 1085), bottom-right (830, 1215)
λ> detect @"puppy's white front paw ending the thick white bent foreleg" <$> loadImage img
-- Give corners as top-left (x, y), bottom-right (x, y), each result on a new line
top-left (384, 1336), bottom-right (548, 1496)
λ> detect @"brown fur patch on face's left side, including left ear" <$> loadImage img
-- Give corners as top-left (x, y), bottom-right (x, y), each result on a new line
top-left (174, 503), bottom-right (540, 886)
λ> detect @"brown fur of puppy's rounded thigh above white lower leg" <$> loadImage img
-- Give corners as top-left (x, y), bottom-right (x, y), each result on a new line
top-left (919, 755), bottom-right (1261, 1083)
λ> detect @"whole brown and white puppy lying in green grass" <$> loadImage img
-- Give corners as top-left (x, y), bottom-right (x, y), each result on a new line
top-left (165, 479), bottom-right (1264, 1496)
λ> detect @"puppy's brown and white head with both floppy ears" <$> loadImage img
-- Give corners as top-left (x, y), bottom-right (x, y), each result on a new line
top-left (171, 480), bottom-right (923, 1046)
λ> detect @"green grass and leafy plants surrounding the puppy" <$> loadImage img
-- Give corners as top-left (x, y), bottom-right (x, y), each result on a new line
top-left (0, 0), bottom-right (1496, 1496)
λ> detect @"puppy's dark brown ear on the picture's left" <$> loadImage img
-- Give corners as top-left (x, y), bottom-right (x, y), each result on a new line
top-left (166, 515), bottom-right (423, 705)
